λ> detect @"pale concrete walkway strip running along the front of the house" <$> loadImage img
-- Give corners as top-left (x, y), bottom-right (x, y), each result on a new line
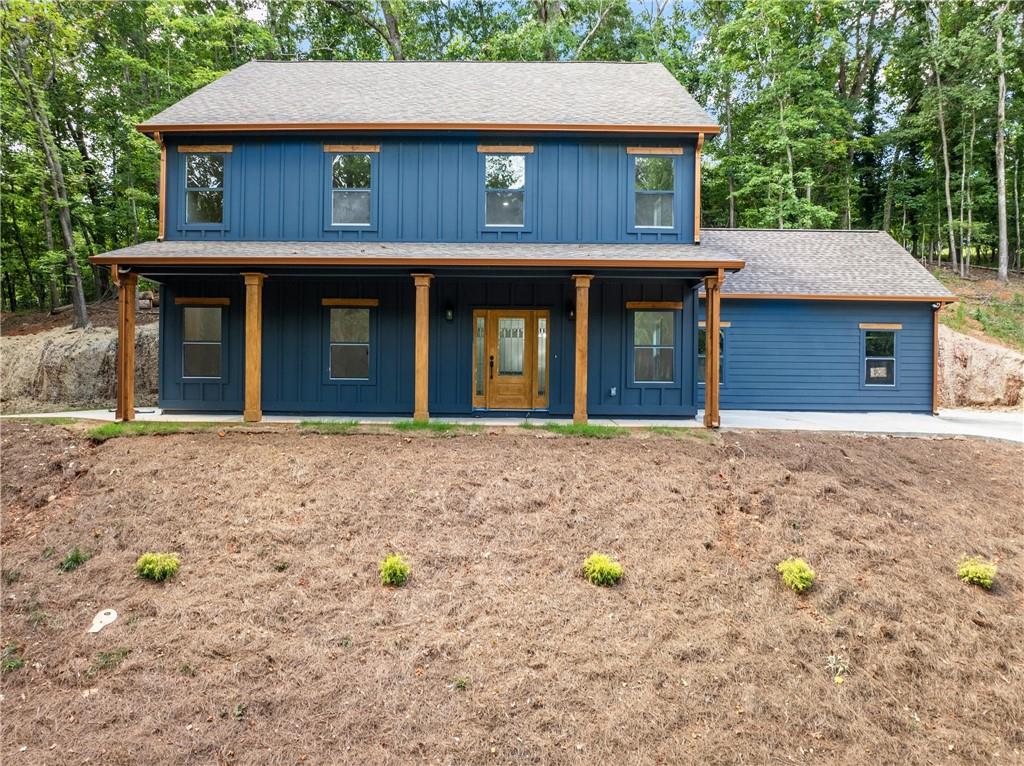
top-left (3, 408), bottom-right (1024, 443)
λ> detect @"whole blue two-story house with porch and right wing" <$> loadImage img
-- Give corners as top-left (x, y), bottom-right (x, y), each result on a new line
top-left (93, 61), bottom-right (952, 426)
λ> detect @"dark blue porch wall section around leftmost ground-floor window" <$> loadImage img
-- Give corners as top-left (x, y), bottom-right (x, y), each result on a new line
top-left (158, 276), bottom-right (245, 412)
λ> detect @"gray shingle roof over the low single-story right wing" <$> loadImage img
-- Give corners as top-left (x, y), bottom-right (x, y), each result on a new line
top-left (700, 228), bottom-right (953, 298)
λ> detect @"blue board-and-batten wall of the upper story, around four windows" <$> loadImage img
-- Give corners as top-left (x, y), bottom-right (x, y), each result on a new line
top-left (167, 134), bottom-right (695, 243)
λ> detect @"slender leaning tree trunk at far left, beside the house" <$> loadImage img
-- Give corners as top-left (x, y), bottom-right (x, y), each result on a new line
top-left (7, 39), bottom-right (92, 328)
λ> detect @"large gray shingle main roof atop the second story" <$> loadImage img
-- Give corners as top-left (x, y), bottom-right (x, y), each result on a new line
top-left (140, 61), bottom-right (717, 131)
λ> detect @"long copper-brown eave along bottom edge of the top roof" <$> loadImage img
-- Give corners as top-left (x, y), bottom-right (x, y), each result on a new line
top-left (135, 122), bottom-right (722, 135)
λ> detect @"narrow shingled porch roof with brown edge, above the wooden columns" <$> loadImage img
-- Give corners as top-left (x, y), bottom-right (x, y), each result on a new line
top-left (89, 241), bottom-right (743, 271)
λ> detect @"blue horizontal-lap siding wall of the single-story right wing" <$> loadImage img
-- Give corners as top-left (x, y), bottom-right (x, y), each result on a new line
top-left (694, 299), bottom-right (932, 412)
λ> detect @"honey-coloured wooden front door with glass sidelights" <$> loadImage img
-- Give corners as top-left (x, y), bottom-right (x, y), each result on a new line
top-left (473, 308), bottom-right (550, 410)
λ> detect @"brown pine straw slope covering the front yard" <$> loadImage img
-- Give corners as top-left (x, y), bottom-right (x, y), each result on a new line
top-left (0, 424), bottom-right (1024, 764)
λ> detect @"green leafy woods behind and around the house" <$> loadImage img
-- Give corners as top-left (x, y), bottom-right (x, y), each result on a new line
top-left (0, 0), bottom-right (1024, 309)
